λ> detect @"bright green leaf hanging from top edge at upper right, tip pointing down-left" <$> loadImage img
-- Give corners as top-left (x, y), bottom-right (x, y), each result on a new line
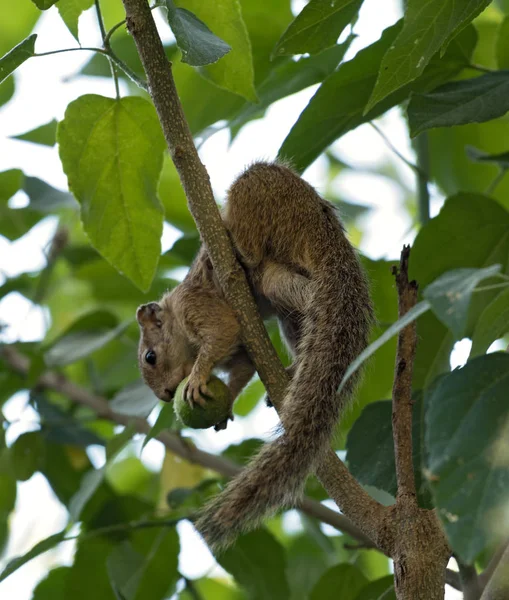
top-left (365, 0), bottom-right (490, 112)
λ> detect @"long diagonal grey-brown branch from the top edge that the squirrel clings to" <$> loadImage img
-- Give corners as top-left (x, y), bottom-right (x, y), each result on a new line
top-left (119, 0), bottom-right (386, 538)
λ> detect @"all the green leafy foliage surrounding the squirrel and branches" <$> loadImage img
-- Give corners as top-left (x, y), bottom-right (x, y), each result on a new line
top-left (0, 0), bottom-right (509, 600)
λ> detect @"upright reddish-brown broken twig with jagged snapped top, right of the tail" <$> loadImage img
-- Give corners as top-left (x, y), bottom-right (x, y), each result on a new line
top-left (392, 246), bottom-right (417, 505)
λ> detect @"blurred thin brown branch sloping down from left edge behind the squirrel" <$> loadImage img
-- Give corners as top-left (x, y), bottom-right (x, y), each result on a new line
top-left (0, 345), bottom-right (374, 548)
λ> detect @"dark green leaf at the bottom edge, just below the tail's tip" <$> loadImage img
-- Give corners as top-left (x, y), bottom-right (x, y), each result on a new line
top-left (217, 529), bottom-right (290, 600)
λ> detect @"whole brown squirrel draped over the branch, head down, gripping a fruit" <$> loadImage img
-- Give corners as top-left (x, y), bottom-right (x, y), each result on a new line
top-left (137, 162), bottom-right (373, 551)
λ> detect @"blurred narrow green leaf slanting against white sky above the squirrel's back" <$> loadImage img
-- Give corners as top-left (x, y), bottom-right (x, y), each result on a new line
top-left (230, 37), bottom-right (353, 127)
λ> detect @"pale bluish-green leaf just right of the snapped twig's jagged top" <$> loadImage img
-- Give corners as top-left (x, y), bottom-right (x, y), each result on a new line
top-left (423, 265), bottom-right (500, 339)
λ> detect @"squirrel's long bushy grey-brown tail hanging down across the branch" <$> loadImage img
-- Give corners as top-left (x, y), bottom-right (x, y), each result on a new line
top-left (196, 247), bottom-right (371, 551)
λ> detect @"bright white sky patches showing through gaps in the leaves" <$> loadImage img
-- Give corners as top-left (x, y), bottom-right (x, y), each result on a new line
top-left (0, 0), bottom-right (460, 600)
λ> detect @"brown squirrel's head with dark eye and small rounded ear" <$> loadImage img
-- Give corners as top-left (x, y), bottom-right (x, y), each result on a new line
top-left (136, 296), bottom-right (194, 402)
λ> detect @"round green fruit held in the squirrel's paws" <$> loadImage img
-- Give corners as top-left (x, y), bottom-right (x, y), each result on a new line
top-left (174, 375), bottom-right (231, 429)
